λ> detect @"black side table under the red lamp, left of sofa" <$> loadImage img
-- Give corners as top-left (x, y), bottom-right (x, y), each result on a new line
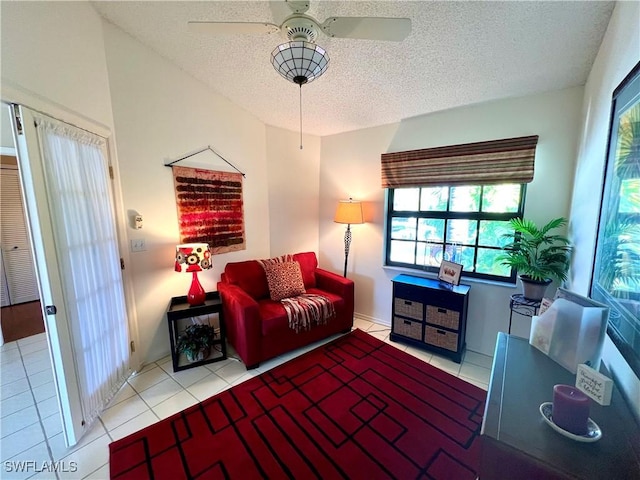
top-left (167, 292), bottom-right (227, 372)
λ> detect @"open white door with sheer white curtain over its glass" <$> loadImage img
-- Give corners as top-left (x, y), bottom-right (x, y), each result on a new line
top-left (5, 99), bottom-right (137, 447)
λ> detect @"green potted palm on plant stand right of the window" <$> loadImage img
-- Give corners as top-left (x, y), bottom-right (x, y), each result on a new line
top-left (498, 217), bottom-right (571, 301)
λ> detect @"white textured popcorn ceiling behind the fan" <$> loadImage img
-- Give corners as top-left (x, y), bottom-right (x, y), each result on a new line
top-left (92, 0), bottom-right (614, 136)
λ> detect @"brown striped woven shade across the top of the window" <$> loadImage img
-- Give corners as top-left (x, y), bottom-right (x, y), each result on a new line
top-left (381, 135), bottom-right (538, 188)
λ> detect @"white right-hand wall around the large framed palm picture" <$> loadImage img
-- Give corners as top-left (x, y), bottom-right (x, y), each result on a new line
top-left (570, 2), bottom-right (640, 418)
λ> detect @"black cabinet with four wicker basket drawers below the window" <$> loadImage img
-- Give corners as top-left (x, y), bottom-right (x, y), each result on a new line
top-left (391, 275), bottom-right (470, 363)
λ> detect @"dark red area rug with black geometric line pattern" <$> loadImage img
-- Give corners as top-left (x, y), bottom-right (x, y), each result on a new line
top-left (109, 330), bottom-right (486, 480)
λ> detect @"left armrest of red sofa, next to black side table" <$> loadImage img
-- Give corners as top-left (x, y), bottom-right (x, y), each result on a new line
top-left (218, 282), bottom-right (262, 367)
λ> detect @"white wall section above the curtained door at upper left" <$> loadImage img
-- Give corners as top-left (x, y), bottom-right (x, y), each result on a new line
top-left (0, 2), bottom-right (113, 127)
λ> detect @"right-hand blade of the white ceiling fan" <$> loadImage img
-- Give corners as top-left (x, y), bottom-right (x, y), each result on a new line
top-left (321, 17), bottom-right (411, 42)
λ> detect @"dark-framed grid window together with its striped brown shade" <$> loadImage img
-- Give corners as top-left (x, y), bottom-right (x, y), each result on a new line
top-left (380, 135), bottom-right (538, 283)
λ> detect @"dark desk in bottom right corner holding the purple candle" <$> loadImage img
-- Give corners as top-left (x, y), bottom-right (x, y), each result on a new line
top-left (479, 333), bottom-right (640, 480)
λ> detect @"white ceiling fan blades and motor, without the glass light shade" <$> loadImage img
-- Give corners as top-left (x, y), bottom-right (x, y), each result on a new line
top-left (188, 0), bottom-right (411, 42)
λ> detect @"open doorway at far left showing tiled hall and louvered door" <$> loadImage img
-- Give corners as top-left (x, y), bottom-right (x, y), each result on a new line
top-left (0, 103), bottom-right (64, 468)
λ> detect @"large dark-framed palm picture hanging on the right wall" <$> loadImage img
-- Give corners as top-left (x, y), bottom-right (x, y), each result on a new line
top-left (590, 62), bottom-right (640, 375)
